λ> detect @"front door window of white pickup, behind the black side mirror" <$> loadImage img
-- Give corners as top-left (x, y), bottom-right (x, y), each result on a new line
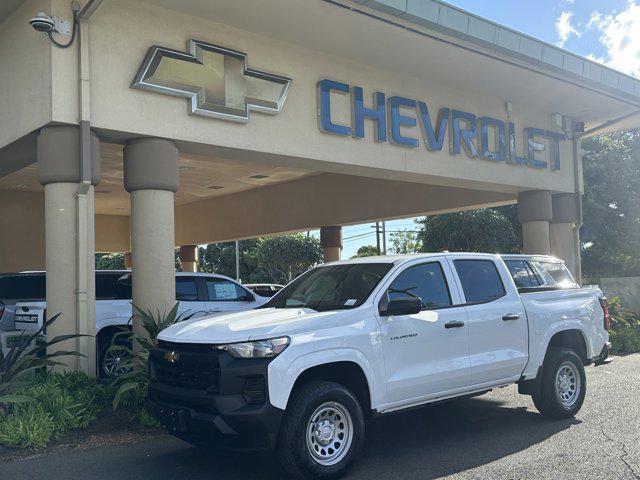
top-left (380, 262), bottom-right (451, 310)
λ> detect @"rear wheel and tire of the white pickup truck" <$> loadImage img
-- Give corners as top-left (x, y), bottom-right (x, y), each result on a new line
top-left (531, 348), bottom-right (587, 419)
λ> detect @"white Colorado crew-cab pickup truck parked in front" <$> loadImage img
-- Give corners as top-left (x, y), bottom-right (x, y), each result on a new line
top-left (149, 253), bottom-right (610, 478)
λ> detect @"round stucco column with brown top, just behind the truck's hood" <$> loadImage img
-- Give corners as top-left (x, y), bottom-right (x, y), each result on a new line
top-left (124, 138), bottom-right (178, 334)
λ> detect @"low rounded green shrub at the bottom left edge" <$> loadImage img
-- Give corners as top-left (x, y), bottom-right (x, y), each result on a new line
top-left (0, 402), bottom-right (55, 448)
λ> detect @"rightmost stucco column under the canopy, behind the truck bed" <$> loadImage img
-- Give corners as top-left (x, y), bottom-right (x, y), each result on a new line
top-left (549, 193), bottom-right (580, 279)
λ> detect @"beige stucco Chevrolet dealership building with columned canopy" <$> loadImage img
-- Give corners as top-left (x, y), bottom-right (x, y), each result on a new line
top-left (0, 0), bottom-right (640, 372)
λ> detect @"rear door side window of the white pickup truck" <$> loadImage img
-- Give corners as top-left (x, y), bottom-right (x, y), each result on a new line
top-left (453, 260), bottom-right (506, 303)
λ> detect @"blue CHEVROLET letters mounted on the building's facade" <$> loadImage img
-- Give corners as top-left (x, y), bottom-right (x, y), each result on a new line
top-left (317, 79), bottom-right (566, 170)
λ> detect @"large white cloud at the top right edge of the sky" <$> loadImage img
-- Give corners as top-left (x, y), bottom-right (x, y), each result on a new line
top-left (587, 0), bottom-right (640, 77)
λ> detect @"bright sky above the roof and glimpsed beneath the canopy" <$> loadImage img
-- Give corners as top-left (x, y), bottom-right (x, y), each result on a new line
top-left (338, 0), bottom-right (640, 258)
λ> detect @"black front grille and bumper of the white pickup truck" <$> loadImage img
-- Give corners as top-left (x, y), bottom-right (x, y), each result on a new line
top-left (149, 343), bottom-right (284, 450)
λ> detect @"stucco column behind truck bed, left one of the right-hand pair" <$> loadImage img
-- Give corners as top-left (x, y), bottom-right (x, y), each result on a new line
top-left (518, 191), bottom-right (553, 255)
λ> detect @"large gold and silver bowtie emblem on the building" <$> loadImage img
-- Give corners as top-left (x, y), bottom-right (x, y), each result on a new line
top-left (131, 40), bottom-right (291, 123)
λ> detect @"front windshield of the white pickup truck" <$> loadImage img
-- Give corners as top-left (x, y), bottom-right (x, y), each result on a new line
top-left (263, 263), bottom-right (393, 312)
